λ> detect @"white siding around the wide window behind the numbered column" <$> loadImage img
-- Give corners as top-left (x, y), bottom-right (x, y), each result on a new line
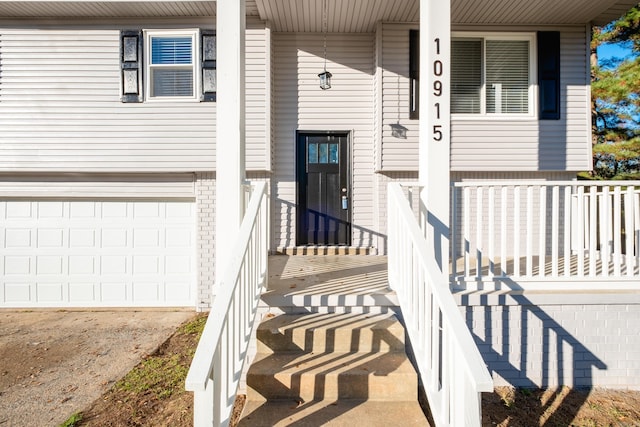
top-left (377, 24), bottom-right (591, 172)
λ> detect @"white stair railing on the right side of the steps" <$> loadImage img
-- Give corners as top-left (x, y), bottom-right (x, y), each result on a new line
top-left (388, 183), bottom-right (493, 427)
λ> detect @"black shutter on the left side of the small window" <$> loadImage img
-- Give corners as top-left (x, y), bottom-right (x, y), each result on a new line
top-left (120, 30), bottom-right (144, 102)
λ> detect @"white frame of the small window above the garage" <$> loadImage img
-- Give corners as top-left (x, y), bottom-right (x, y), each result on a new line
top-left (143, 28), bottom-right (201, 102)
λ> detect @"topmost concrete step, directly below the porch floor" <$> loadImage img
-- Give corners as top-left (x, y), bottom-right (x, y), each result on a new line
top-left (257, 313), bottom-right (405, 353)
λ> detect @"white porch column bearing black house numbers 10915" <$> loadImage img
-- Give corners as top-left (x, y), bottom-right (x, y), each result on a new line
top-left (419, 0), bottom-right (451, 275)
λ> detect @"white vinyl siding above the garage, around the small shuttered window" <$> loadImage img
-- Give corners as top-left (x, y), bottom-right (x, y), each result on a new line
top-left (0, 19), bottom-right (269, 172)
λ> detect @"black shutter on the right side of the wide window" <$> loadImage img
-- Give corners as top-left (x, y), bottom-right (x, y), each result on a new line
top-left (538, 31), bottom-right (560, 120)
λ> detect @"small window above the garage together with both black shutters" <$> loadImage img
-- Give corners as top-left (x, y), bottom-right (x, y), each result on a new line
top-left (120, 29), bottom-right (217, 102)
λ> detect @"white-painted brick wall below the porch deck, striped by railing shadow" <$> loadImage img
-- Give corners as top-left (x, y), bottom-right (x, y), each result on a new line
top-left (461, 295), bottom-right (640, 389)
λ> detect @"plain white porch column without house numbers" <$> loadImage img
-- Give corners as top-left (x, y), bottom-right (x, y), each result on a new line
top-left (214, 0), bottom-right (246, 284)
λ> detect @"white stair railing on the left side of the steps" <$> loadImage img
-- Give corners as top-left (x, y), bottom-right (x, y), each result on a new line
top-left (186, 182), bottom-right (269, 426)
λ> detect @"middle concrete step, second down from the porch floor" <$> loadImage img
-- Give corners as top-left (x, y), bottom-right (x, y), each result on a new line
top-left (247, 352), bottom-right (418, 402)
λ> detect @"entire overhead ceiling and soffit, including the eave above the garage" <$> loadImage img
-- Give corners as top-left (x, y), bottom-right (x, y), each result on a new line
top-left (0, 0), bottom-right (637, 26)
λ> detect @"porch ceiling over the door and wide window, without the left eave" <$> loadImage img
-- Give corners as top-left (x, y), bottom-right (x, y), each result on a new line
top-left (256, 0), bottom-right (637, 32)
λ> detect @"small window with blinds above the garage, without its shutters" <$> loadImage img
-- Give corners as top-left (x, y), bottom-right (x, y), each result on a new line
top-left (146, 30), bottom-right (197, 99)
